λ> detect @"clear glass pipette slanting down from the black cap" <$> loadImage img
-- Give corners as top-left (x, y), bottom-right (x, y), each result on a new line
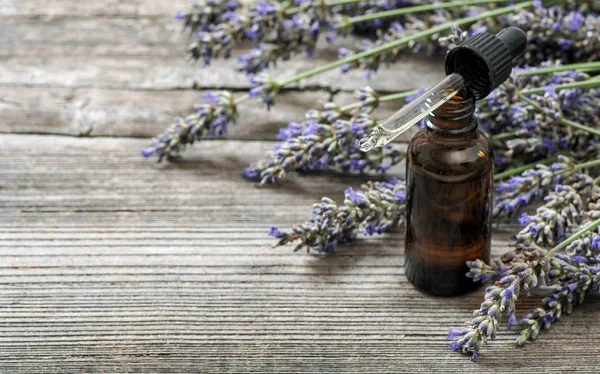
top-left (358, 73), bottom-right (465, 152)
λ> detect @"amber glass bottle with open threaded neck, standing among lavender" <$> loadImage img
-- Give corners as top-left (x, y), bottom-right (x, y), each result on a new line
top-left (405, 89), bottom-right (494, 296)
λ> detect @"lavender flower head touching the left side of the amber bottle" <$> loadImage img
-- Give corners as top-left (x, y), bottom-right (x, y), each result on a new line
top-left (269, 179), bottom-right (406, 253)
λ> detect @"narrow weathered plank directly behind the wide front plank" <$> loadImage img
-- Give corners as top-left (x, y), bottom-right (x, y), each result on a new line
top-left (0, 87), bottom-right (416, 140)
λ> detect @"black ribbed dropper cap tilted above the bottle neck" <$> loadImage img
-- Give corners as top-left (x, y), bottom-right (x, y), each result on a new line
top-left (446, 27), bottom-right (527, 100)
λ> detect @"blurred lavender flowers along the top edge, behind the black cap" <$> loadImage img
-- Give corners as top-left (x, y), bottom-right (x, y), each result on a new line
top-left (175, 0), bottom-right (600, 73)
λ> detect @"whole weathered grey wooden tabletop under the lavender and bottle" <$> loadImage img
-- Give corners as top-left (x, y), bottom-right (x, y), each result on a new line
top-left (0, 0), bottom-right (600, 373)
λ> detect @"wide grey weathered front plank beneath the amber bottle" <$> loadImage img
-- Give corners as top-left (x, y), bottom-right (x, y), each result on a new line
top-left (0, 135), bottom-right (600, 373)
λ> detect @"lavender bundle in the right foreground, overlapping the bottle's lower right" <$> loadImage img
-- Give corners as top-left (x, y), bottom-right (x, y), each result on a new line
top-left (447, 186), bottom-right (600, 361)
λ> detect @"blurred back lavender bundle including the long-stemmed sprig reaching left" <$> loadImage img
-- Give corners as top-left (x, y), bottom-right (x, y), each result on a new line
top-left (143, 0), bottom-right (600, 160)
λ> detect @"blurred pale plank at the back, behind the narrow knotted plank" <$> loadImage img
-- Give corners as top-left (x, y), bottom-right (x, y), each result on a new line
top-left (0, 18), bottom-right (443, 91)
